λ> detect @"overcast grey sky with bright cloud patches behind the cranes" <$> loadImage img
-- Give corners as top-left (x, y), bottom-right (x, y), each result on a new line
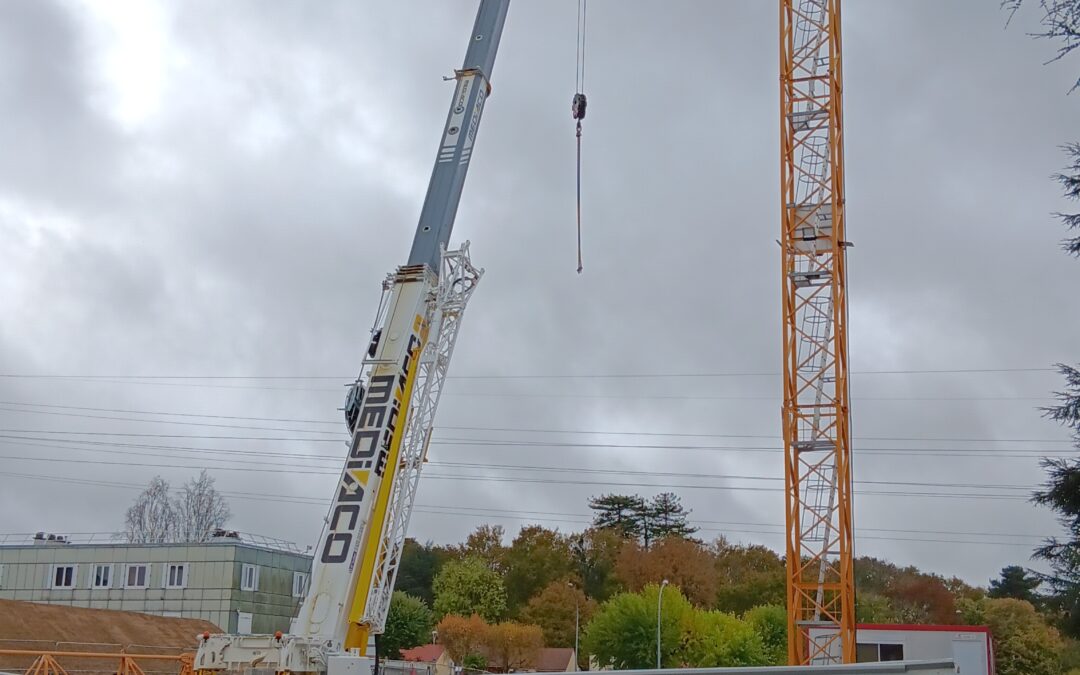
top-left (0, 0), bottom-right (1080, 584)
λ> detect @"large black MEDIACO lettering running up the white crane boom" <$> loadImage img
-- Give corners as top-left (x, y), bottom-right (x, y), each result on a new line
top-left (321, 332), bottom-right (421, 564)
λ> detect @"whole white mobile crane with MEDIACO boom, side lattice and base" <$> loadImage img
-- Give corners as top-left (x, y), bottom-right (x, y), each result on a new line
top-left (194, 0), bottom-right (510, 675)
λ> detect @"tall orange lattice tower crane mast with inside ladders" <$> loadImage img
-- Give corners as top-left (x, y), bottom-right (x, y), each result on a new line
top-left (780, 0), bottom-right (855, 664)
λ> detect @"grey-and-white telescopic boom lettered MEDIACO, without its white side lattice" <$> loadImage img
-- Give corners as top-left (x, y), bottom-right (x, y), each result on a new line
top-left (296, 0), bottom-right (510, 653)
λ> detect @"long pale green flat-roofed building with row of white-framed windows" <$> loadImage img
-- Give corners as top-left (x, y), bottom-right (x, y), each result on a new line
top-left (0, 531), bottom-right (311, 633)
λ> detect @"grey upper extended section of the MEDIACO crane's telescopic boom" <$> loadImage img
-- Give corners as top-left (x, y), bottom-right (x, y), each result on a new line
top-left (408, 0), bottom-right (510, 274)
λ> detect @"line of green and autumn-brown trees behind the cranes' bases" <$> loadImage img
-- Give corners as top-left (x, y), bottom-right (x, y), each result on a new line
top-left (380, 495), bottom-right (1080, 675)
